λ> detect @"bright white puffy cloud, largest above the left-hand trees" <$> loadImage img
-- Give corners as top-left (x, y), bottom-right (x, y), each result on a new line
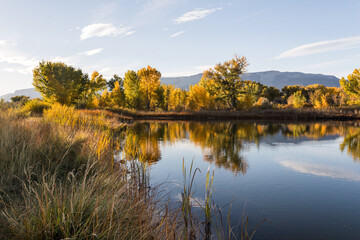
top-left (80, 23), bottom-right (134, 40)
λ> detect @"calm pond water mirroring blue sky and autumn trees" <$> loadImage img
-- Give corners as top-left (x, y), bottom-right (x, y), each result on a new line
top-left (118, 122), bottom-right (360, 240)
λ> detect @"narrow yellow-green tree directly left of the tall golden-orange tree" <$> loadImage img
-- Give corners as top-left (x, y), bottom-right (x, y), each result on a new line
top-left (124, 70), bottom-right (141, 109)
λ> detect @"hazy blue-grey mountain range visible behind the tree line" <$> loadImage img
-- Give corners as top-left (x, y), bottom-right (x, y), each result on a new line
top-left (0, 71), bottom-right (340, 101)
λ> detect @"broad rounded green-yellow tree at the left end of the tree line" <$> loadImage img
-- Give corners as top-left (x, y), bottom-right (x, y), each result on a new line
top-left (33, 61), bottom-right (90, 105)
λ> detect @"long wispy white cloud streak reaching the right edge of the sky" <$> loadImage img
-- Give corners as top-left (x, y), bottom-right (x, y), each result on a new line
top-left (275, 36), bottom-right (360, 59)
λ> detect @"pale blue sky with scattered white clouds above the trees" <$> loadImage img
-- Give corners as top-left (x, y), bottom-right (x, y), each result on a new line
top-left (0, 0), bottom-right (360, 96)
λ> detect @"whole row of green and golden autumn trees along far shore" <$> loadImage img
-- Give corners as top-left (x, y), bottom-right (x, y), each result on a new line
top-left (23, 56), bottom-right (360, 111)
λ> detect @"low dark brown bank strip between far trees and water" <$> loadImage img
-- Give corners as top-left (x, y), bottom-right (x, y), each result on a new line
top-left (106, 107), bottom-right (360, 122)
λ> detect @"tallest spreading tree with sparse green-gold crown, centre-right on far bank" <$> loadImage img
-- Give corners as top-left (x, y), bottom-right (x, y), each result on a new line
top-left (203, 56), bottom-right (248, 109)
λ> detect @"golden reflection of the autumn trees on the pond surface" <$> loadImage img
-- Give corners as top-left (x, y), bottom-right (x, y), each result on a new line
top-left (123, 122), bottom-right (360, 174)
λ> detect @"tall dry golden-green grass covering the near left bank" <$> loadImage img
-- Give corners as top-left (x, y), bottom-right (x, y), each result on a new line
top-left (0, 109), bottom-right (174, 239)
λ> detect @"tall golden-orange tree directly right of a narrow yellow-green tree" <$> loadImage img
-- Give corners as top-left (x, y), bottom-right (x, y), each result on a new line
top-left (137, 66), bottom-right (161, 110)
